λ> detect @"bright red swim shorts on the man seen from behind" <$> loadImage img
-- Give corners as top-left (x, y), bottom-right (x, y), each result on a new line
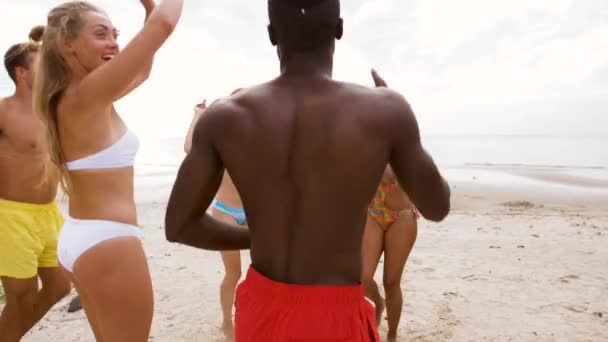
top-left (235, 267), bottom-right (380, 342)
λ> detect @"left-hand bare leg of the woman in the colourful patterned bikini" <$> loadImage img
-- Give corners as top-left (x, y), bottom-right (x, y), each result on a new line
top-left (362, 216), bottom-right (384, 325)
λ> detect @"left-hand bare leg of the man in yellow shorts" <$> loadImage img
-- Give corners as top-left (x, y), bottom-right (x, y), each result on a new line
top-left (0, 277), bottom-right (38, 342)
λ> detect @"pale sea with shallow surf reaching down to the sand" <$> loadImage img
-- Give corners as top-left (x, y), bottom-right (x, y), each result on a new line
top-left (136, 135), bottom-right (608, 190)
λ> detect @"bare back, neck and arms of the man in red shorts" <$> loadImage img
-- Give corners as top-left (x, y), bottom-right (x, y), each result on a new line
top-left (166, 12), bottom-right (450, 285)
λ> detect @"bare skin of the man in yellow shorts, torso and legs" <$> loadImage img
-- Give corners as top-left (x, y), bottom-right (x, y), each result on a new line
top-left (0, 53), bottom-right (70, 342)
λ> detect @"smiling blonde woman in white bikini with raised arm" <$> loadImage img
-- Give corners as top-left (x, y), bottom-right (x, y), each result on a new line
top-left (34, 0), bottom-right (183, 342)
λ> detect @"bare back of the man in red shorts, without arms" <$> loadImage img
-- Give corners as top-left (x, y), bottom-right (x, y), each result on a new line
top-left (209, 78), bottom-right (408, 285)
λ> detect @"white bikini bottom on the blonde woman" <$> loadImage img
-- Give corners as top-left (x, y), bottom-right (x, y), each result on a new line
top-left (57, 217), bottom-right (141, 272)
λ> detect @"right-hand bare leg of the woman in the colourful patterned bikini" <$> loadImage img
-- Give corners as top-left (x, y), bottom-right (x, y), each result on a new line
top-left (383, 213), bottom-right (418, 342)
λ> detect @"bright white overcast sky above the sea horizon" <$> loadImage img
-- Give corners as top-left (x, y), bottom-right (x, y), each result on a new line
top-left (0, 0), bottom-right (608, 136)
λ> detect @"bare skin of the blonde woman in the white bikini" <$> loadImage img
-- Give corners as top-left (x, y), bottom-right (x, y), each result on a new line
top-left (46, 0), bottom-right (183, 342)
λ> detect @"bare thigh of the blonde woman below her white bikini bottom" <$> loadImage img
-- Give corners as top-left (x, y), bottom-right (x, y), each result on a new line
top-left (73, 237), bottom-right (154, 342)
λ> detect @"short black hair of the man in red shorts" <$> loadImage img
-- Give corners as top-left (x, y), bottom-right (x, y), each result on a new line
top-left (268, 0), bottom-right (341, 51)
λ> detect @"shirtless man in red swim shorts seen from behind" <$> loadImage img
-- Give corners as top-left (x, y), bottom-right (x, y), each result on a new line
top-left (165, 0), bottom-right (450, 342)
